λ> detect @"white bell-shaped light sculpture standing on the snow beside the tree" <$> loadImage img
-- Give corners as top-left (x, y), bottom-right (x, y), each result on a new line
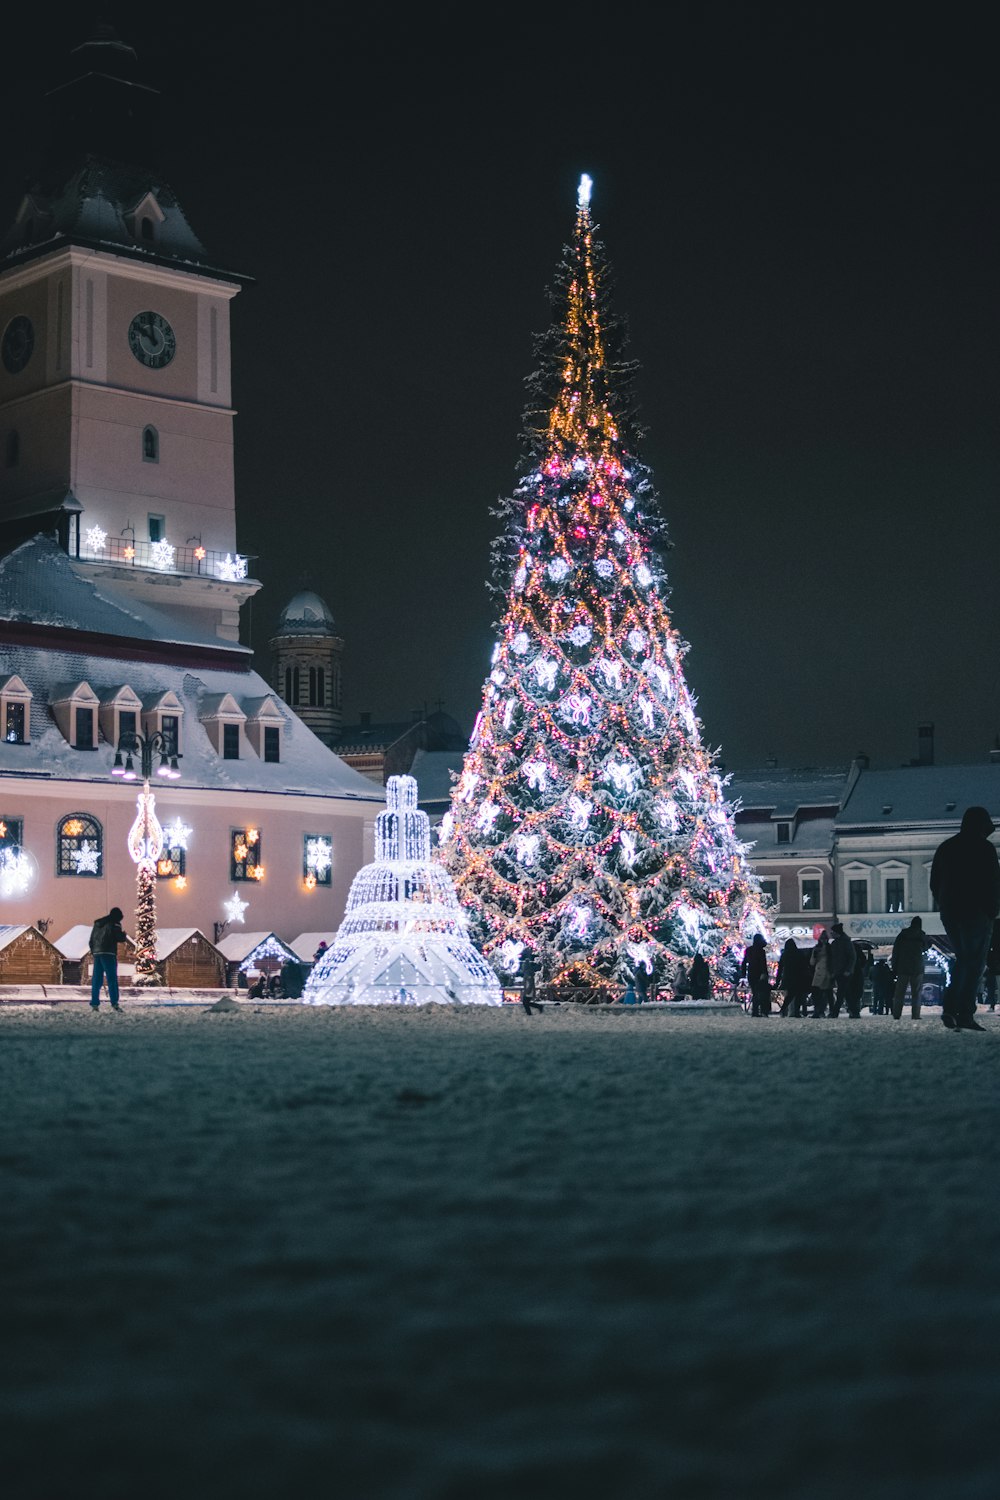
top-left (303, 776), bottom-right (502, 1005)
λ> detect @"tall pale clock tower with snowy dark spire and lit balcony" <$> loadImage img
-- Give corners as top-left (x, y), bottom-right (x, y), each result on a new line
top-left (0, 26), bottom-right (259, 642)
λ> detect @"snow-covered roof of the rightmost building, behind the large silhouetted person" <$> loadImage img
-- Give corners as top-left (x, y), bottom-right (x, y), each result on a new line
top-left (837, 761), bottom-right (1000, 833)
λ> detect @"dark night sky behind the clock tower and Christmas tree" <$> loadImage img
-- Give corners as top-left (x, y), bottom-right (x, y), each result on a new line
top-left (0, 3), bottom-right (1000, 770)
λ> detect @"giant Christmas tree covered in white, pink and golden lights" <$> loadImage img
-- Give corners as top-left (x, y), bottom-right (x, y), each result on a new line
top-left (439, 177), bottom-right (768, 986)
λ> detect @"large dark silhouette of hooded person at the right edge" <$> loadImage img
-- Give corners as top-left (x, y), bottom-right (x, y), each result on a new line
top-left (931, 807), bottom-right (1000, 1031)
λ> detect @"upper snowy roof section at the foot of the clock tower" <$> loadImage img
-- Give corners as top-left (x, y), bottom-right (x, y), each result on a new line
top-left (0, 536), bottom-right (252, 662)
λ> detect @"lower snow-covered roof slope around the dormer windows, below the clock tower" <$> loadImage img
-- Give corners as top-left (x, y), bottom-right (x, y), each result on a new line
top-left (0, 642), bottom-right (384, 804)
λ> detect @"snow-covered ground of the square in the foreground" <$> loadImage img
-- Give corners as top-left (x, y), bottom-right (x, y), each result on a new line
top-left (0, 1002), bottom-right (1000, 1500)
